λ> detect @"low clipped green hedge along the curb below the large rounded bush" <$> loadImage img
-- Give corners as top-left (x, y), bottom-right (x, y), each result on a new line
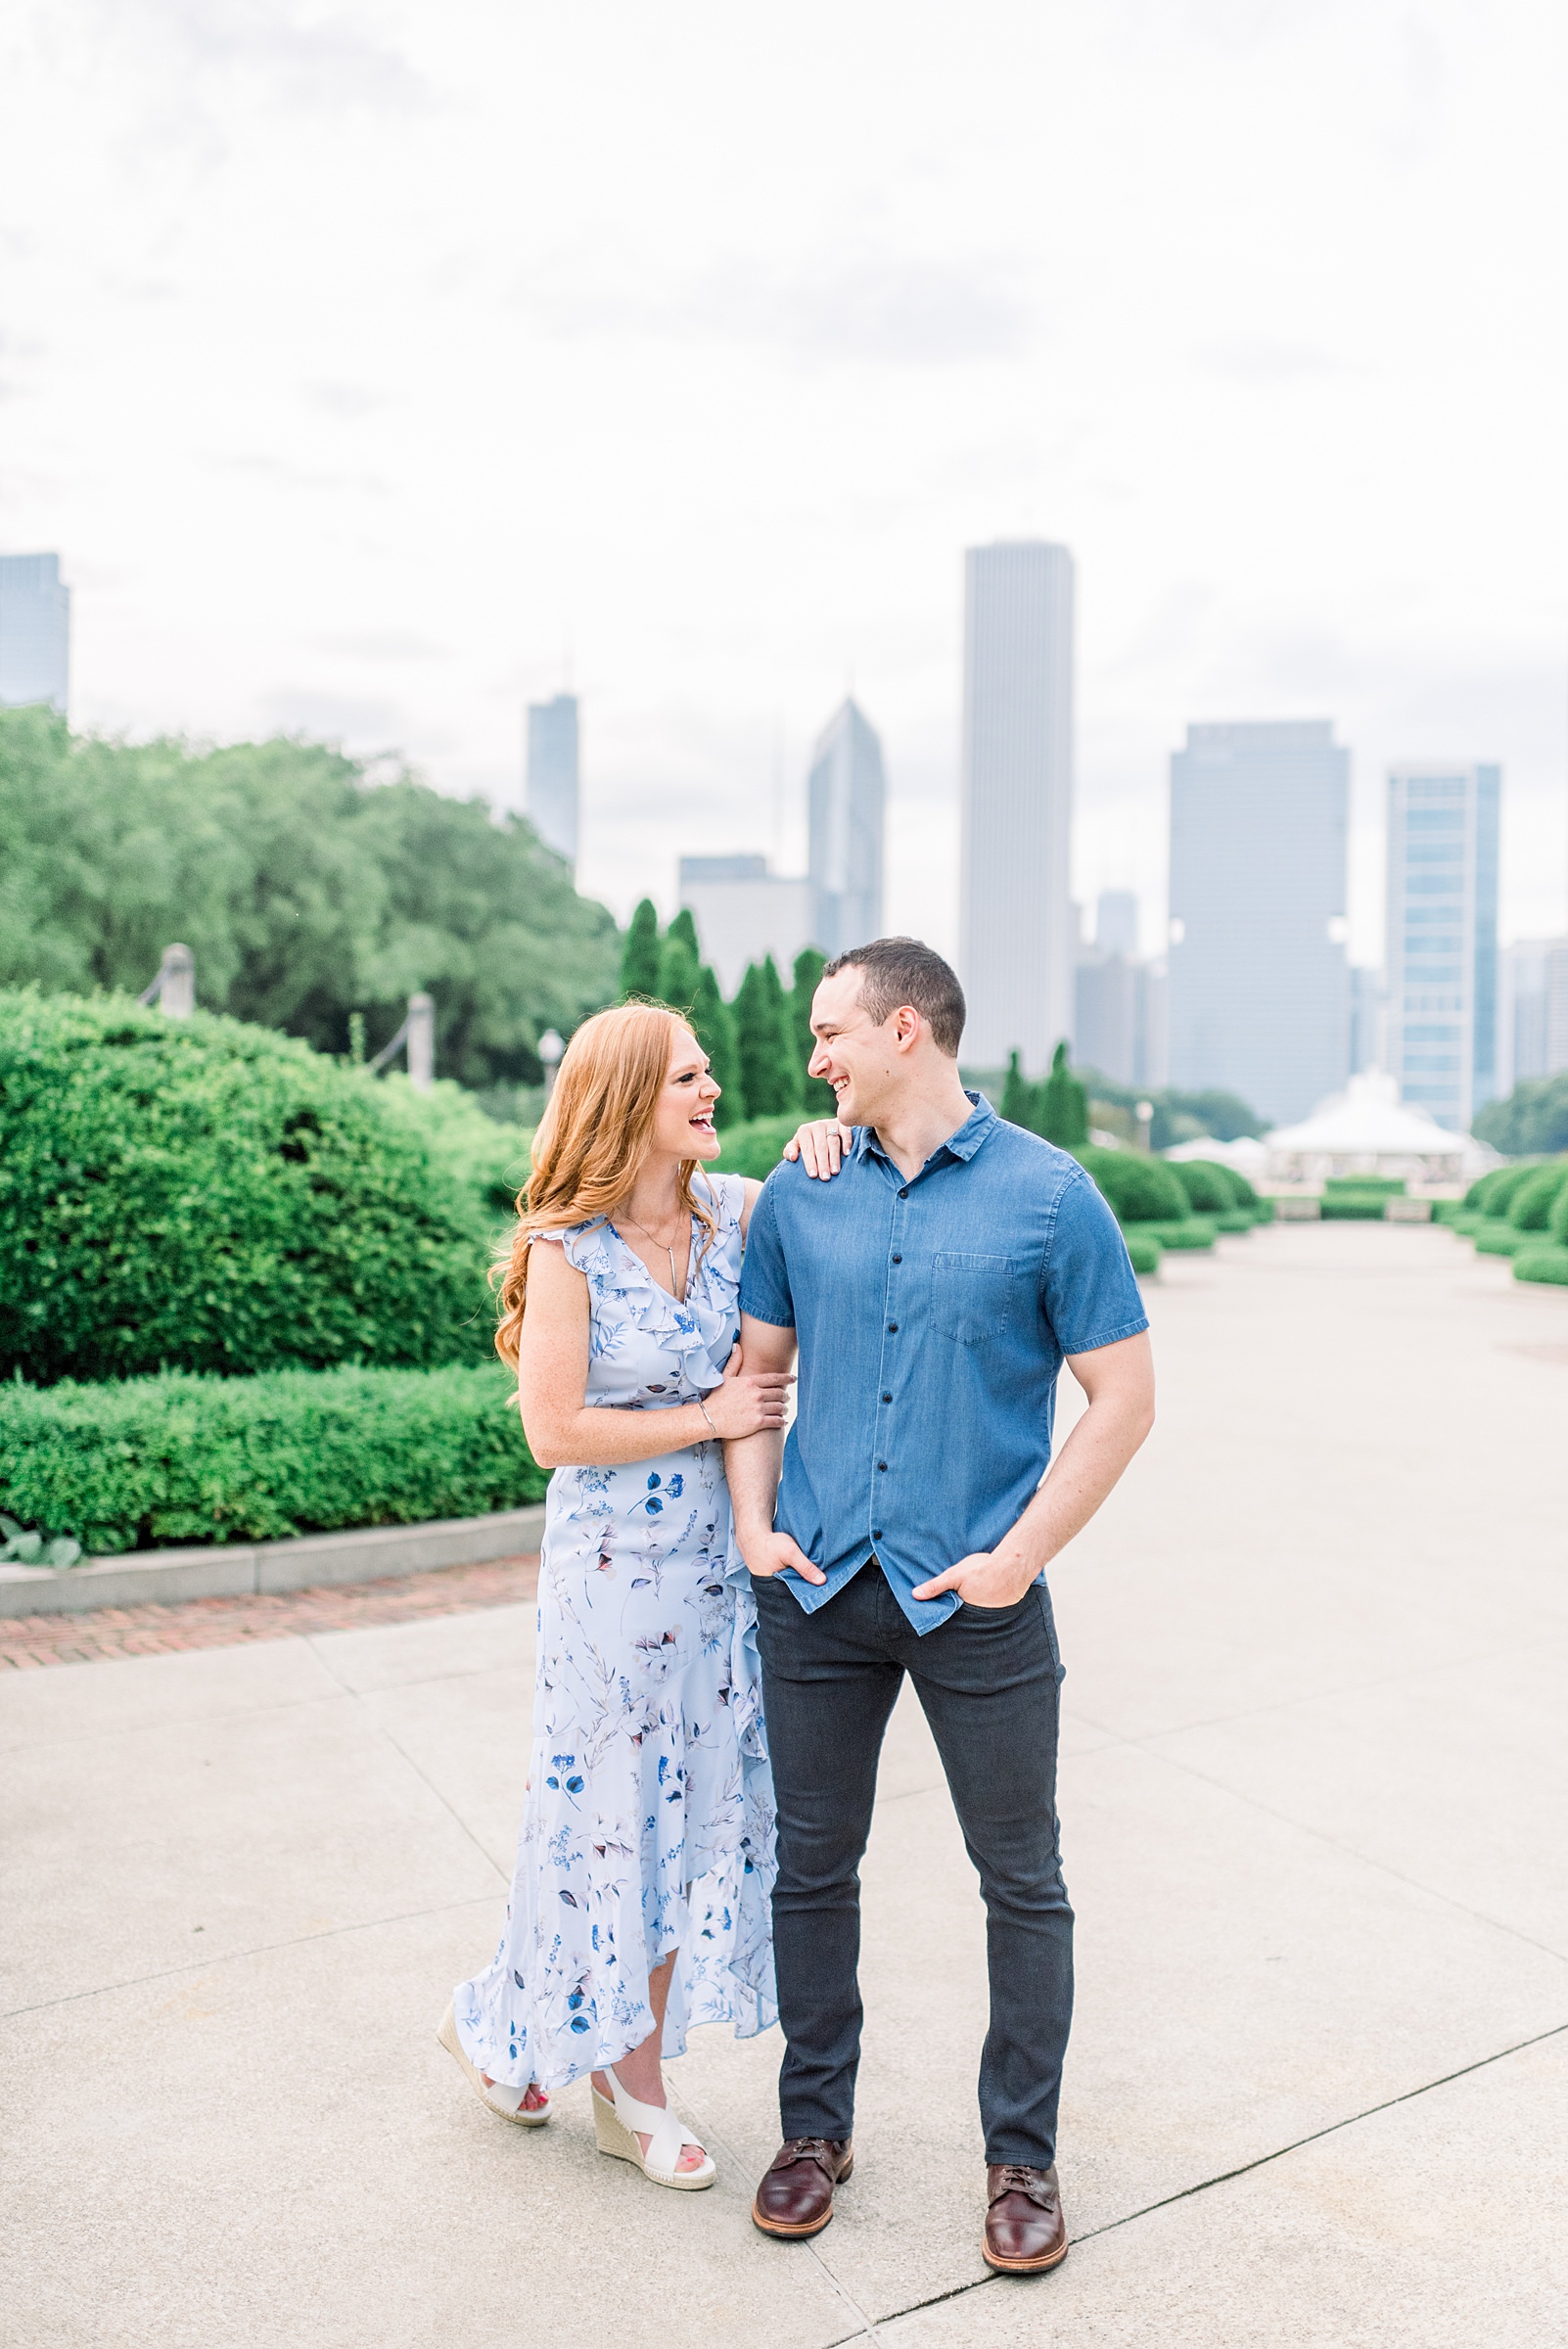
top-left (0, 1362), bottom-right (547, 1552)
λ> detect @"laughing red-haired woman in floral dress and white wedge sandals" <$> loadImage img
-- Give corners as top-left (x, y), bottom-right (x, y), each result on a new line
top-left (438, 1003), bottom-right (830, 2191)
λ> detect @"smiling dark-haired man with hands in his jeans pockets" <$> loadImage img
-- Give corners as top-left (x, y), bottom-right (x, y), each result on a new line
top-left (725, 938), bottom-right (1155, 2274)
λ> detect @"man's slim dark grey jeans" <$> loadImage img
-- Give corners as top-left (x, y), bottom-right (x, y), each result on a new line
top-left (751, 1560), bottom-right (1073, 2168)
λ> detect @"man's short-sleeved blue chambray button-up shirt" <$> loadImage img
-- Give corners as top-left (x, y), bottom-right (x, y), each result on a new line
top-left (739, 1092), bottom-right (1148, 1633)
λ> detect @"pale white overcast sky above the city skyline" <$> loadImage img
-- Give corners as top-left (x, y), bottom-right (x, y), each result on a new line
top-left (0, 0), bottom-right (1568, 958)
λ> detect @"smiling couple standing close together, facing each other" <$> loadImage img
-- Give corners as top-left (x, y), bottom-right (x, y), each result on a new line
top-left (441, 938), bottom-right (1153, 2274)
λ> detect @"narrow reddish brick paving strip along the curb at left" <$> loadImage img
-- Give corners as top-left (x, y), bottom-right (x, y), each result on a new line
top-left (0, 1555), bottom-right (540, 1673)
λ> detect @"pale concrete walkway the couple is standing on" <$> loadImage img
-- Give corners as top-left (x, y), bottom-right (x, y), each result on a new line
top-left (0, 1223), bottom-right (1568, 2349)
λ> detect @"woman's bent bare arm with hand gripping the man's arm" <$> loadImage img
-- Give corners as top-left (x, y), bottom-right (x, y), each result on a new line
top-left (517, 1240), bottom-right (789, 1468)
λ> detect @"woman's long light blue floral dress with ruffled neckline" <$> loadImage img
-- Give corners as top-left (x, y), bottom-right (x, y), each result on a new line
top-left (453, 1174), bottom-right (777, 2089)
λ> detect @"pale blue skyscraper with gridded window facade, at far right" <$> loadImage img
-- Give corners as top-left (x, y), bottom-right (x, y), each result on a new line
top-left (1387, 765), bottom-right (1502, 1132)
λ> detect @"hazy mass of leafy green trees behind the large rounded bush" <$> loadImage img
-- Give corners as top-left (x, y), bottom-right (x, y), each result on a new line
top-left (0, 710), bottom-right (620, 1087)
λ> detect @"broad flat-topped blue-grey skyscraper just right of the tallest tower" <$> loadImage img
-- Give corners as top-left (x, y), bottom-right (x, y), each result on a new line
top-left (1169, 718), bottom-right (1350, 1126)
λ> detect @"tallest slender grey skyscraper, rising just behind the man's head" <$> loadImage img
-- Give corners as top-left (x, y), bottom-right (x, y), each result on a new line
top-left (957, 540), bottom-right (1078, 1076)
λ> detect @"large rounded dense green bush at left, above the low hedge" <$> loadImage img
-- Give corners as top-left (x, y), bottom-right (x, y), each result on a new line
top-left (0, 991), bottom-right (495, 1384)
